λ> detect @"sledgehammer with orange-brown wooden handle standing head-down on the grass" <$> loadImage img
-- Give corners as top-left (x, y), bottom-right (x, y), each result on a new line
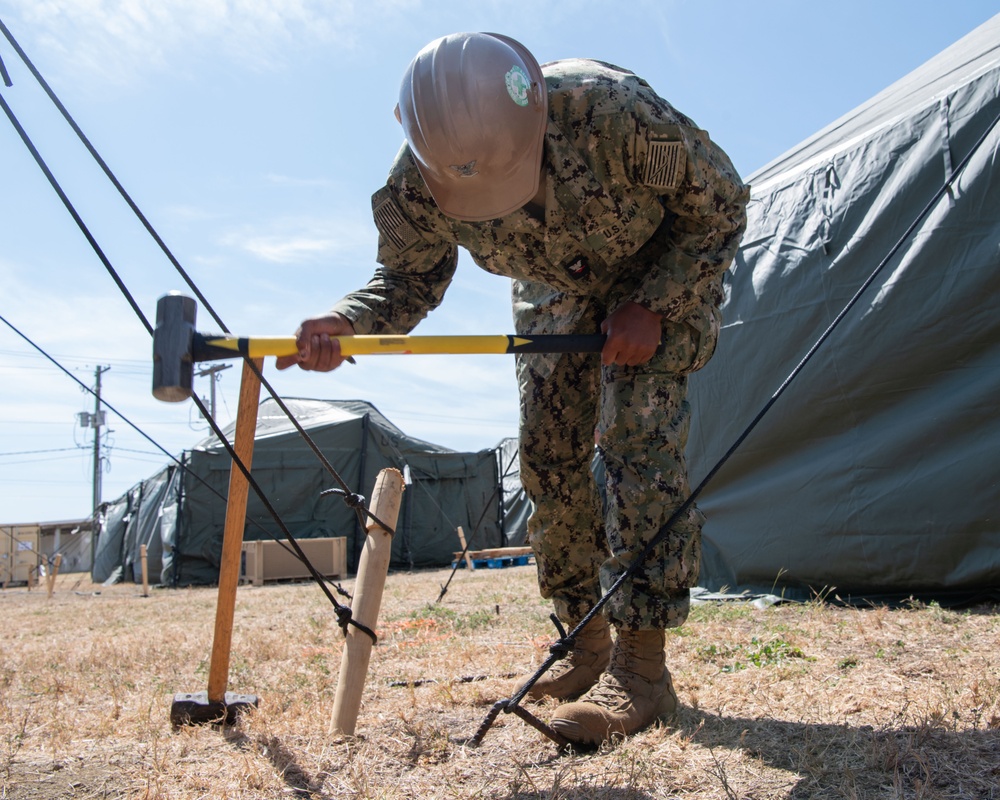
top-left (170, 359), bottom-right (264, 725)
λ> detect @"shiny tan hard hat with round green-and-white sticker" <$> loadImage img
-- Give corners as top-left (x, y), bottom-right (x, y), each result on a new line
top-left (396, 33), bottom-right (548, 221)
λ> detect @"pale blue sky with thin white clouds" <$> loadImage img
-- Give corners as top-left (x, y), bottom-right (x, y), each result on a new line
top-left (0, 0), bottom-right (997, 523)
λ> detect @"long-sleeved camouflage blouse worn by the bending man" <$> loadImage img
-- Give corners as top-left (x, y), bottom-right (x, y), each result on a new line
top-left (333, 59), bottom-right (748, 338)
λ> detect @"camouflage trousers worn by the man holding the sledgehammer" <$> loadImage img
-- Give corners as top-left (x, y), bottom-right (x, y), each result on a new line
top-left (514, 283), bottom-right (703, 629)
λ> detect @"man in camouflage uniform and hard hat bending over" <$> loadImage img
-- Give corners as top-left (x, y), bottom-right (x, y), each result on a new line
top-left (278, 33), bottom-right (748, 744)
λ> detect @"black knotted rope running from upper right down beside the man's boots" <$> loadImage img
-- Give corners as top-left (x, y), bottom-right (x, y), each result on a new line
top-left (470, 95), bottom-right (1000, 746)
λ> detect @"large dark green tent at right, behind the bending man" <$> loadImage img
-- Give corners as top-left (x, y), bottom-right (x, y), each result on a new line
top-left (688, 16), bottom-right (1000, 599)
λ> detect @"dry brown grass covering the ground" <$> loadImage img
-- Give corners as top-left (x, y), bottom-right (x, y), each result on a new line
top-left (0, 567), bottom-right (1000, 800)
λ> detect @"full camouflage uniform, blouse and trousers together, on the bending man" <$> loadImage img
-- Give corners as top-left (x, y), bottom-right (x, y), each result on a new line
top-left (333, 59), bottom-right (748, 628)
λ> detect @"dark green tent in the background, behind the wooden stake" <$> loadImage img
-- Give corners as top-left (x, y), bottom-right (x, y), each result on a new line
top-left (93, 399), bottom-right (528, 586)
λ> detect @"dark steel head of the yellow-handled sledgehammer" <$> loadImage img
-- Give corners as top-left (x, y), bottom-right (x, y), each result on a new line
top-left (153, 292), bottom-right (197, 403)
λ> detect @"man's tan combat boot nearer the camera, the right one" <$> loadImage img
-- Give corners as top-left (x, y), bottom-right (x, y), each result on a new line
top-left (551, 630), bottom-right (677, 745)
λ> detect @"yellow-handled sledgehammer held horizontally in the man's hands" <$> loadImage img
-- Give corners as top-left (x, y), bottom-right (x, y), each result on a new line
top-left (147, 292), bottom-right (605, 402)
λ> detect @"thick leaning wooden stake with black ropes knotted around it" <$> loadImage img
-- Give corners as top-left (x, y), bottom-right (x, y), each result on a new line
top-left (330, 469), bottom-right (404, 735)
